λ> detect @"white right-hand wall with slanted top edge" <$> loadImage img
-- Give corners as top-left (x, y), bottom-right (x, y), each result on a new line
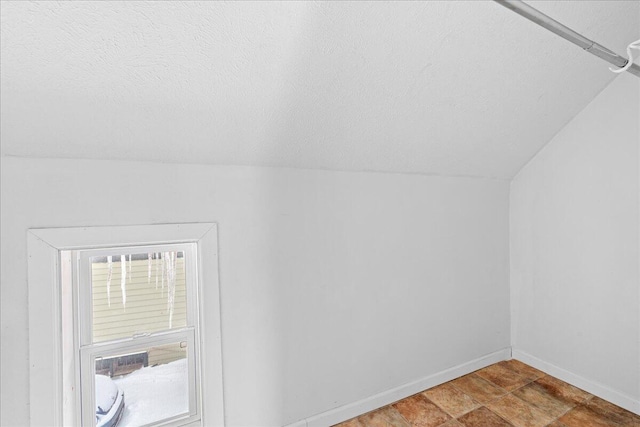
top-left (510, 75), bottom-right (640, 412)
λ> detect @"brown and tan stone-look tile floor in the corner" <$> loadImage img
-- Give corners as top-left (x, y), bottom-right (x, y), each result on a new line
top-left (336, 360), bottom-right (640, 427)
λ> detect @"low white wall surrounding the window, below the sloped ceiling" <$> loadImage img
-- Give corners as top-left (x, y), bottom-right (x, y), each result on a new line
top-left (0, 158), bottom-right (509, 426)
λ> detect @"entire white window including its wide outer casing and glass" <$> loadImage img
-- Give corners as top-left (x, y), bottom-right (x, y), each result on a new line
top-left (29, 224), bottom-right (223, 427)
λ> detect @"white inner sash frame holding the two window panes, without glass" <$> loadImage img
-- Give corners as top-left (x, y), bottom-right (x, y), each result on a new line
top-left (76, 243), bottom-right (201, 427)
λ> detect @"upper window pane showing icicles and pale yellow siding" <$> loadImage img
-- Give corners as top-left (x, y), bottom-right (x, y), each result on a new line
top-left (91, 251), bottom-right (187, 342)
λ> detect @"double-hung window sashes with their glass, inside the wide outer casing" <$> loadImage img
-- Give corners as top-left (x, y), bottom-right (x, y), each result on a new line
top-left (69, 243), bottom-right (200, 427)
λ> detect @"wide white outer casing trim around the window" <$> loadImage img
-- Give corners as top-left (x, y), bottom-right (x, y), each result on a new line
top-left (27, 223), bottom-right (224, 426)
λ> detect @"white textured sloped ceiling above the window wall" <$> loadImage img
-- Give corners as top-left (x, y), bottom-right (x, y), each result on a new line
top-left (0, 1), bottom-right (640, 179)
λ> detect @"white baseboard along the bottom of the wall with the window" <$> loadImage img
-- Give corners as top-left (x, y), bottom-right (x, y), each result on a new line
top-left (285, 347), bottom-right (511, 427)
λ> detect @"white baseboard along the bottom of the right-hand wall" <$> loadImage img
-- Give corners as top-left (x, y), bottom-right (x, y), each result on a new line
top-left (513, 349), bottom-right (640, 415)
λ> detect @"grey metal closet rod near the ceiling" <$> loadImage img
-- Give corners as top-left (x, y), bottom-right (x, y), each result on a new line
top-left (494, 0), bottom-right (640, 77)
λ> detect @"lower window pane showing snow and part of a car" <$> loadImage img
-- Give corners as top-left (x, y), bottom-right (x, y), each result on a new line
top-left (95, 342), bottom-right (189, 427)
